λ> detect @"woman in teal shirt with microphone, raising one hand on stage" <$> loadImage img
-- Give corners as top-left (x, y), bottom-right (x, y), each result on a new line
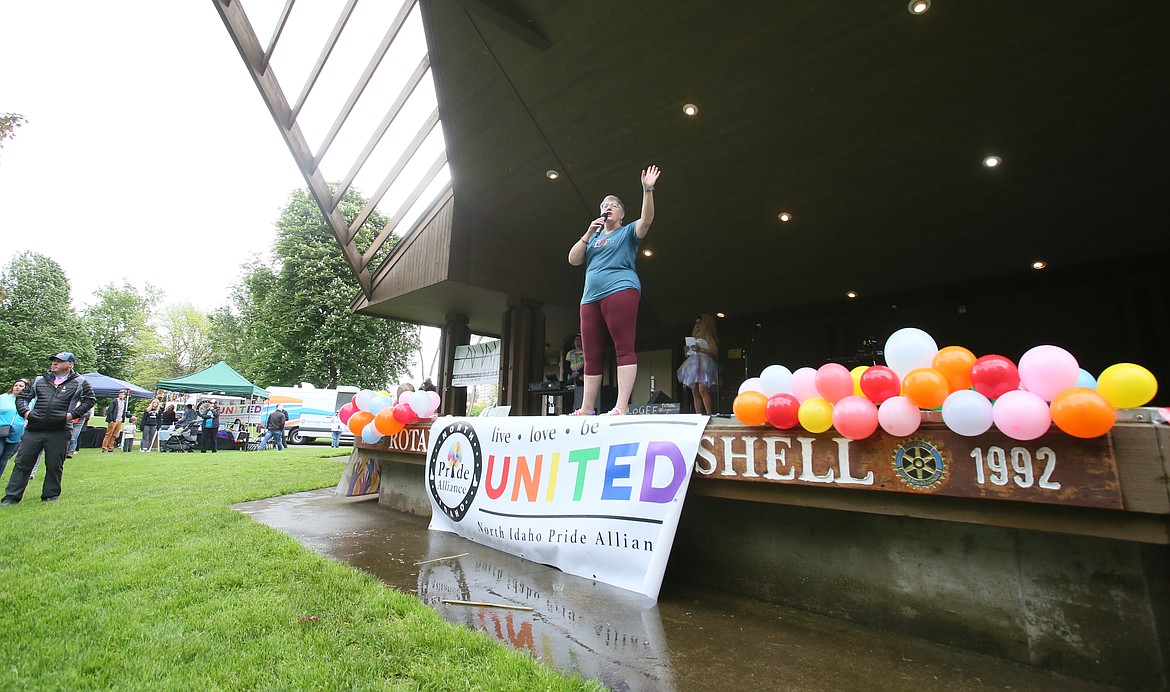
top-left (569, 165), bottom-right (660, 416)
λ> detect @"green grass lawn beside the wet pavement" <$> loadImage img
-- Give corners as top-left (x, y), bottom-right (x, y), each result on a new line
top-left (0, 445), bottom-right (597, 690)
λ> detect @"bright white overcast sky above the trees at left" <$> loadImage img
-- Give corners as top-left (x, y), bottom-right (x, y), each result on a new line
top-left (0, 0), bottom-right (431, 379)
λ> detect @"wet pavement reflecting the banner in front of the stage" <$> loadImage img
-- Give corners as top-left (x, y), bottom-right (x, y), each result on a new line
top-left (235, 488), bottom-right (1110, 692)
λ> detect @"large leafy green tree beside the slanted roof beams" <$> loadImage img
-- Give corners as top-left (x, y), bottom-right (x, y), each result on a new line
top-left (221, 190), bottom-right (419, 389)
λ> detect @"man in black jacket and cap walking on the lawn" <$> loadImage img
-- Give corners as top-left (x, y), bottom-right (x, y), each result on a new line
top-left (0, 351), bottom-right (97, 505)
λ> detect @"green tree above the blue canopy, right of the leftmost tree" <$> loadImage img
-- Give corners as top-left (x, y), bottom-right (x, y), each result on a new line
top-left (82, 282), bottom-right (161, 379)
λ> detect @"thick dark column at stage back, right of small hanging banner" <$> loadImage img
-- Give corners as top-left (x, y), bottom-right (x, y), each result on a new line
top-left (500, 299), bottom-right (545, 416)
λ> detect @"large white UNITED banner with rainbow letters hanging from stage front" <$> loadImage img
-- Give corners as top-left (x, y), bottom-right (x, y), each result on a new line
top-left (426, 416), bottom-right (707, 598)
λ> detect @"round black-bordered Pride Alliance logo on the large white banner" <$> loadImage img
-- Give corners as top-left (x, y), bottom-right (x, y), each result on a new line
top-left (427, 423), bottom-right (483, 522)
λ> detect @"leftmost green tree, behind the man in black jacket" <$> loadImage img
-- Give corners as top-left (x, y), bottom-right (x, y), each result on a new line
top-left (0, 252), bottom-right (95, 389)
